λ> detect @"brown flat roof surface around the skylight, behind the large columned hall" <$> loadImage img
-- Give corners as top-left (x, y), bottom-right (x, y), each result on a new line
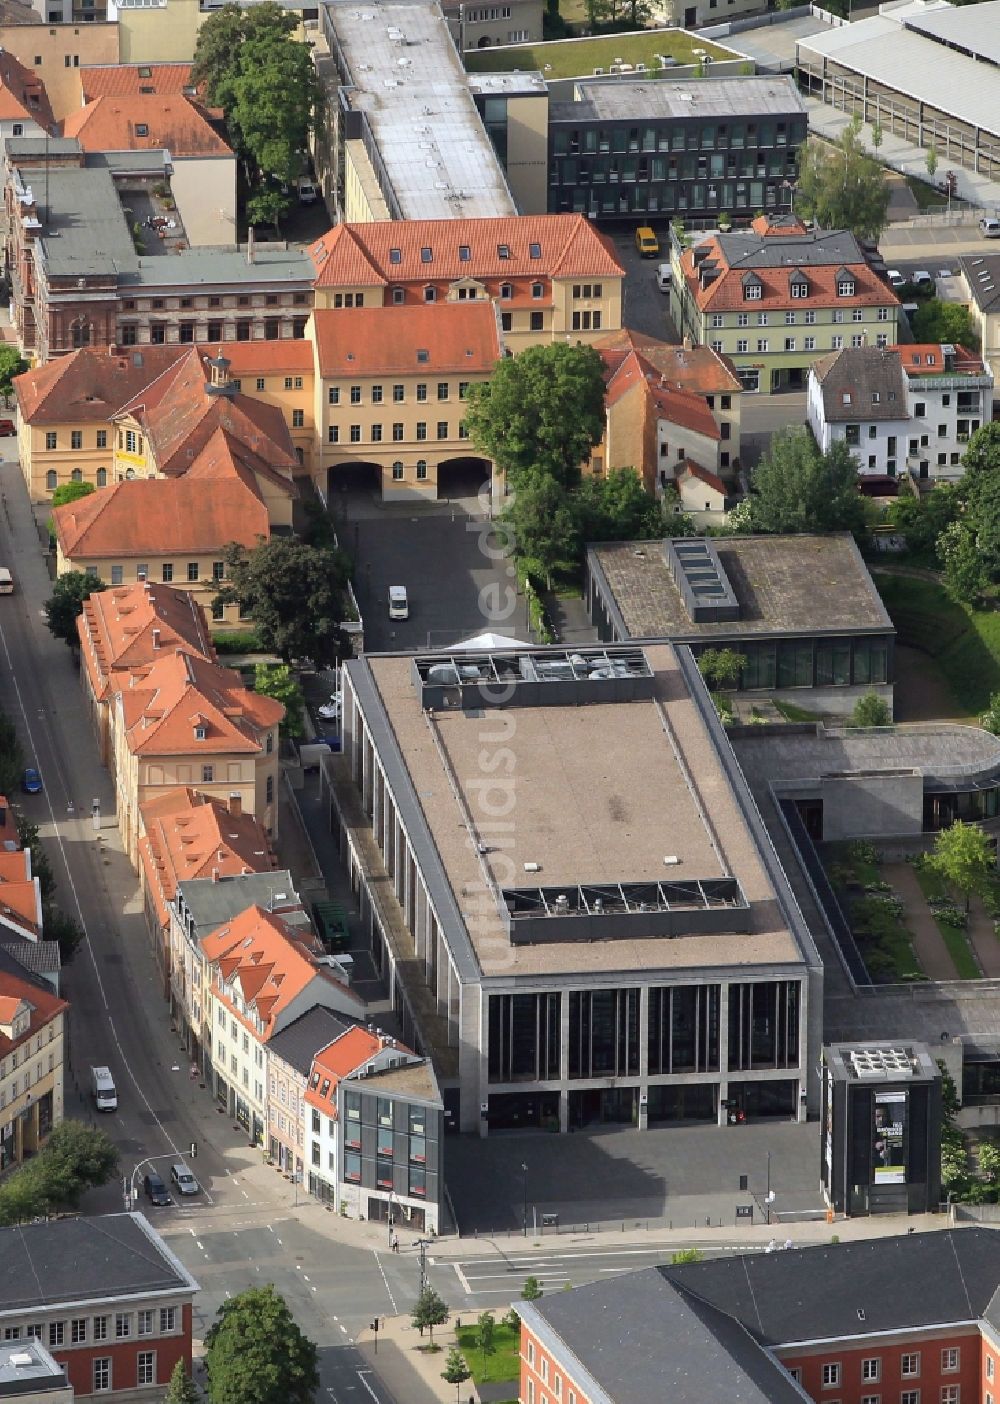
top-left (587, 534), bottom-right (895, 640)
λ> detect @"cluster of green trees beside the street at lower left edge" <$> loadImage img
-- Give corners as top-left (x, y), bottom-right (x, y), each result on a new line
top-left (0, 1122), bottom-right (118, 1227)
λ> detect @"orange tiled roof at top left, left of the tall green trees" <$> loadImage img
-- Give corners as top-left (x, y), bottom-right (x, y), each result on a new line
top-left (63, 94), bottom-right (233, 160)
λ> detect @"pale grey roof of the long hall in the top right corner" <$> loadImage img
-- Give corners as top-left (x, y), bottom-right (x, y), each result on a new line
top-left (798, 6), bottom-right (1000, 136)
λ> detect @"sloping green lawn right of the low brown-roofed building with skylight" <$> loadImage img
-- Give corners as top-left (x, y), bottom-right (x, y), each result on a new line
top-left (874, 569), bottom-right (1000, 716)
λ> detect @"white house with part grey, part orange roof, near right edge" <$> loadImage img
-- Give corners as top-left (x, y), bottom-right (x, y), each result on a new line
top-left (806, 344), bottom-right (993, 486)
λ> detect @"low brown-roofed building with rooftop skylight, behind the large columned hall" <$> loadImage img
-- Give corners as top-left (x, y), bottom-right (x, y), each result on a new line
top-left (587, 535), bottom-right (895, 715)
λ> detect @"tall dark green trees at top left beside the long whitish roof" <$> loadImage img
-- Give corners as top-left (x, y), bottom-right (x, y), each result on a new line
top-left (191, 0), bottom-right (319, 225)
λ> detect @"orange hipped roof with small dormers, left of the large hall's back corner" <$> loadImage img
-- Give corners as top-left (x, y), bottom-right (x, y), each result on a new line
top-left (117, 649), bottom-right (285, 758)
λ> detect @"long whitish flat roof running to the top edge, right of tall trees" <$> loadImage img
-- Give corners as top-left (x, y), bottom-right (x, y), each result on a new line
top-left (323, 0), bottom-right (517, 219)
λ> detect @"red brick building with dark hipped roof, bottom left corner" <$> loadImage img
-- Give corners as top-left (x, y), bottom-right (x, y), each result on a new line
top-left (0, 1213), bottom-right (198, 1404)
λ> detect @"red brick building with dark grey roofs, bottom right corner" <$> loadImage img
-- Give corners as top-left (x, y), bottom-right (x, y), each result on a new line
top-left (517, 1227), bottom-right (1000, 1404)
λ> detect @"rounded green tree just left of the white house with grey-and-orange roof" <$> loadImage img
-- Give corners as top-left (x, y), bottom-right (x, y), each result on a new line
top-left (746, 430), bottom-right (868, 536)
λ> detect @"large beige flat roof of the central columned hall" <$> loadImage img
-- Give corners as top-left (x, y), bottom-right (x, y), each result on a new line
top-left (355, 643), bottom-right (815, 980)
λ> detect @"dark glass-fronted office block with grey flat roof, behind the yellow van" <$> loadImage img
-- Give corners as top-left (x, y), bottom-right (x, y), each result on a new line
top-left (548, 76), bottom-right (806, 226)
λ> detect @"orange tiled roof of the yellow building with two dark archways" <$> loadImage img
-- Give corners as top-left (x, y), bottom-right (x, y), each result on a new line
top-left (313, 299), bottom-right (501, 378)
